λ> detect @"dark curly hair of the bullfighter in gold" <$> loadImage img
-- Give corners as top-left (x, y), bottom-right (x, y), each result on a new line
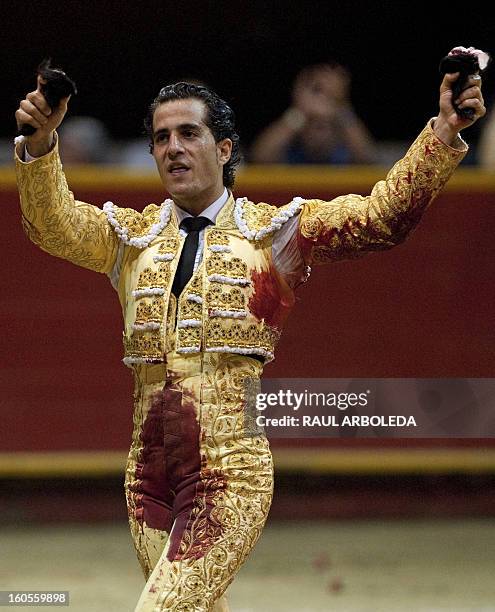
top-left (144, 81), bottom-right (241, 187)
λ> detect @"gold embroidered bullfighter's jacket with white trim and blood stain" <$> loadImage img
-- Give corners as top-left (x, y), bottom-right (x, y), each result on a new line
top-left (16, 124), bottom-right (467, 365)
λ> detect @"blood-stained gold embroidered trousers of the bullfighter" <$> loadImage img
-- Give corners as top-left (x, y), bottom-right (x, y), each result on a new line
top-left (125, 351), bottom-right (273, 612)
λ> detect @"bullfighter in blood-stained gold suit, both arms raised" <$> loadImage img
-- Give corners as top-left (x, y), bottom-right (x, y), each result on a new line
top-left (15, 62), bottom-right (485, 612)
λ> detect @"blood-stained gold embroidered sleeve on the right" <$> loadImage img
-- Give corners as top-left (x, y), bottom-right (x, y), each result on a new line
top-left (298, 123), bottom-right (467, 265)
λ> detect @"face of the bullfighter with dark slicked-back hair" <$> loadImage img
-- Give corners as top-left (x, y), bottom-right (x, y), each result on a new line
top-left (153, 98), bottom-right (232, 209)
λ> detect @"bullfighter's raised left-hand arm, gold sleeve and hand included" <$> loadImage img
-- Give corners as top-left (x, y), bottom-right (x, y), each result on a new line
top-left (15, 77), bottom-right (118, 273)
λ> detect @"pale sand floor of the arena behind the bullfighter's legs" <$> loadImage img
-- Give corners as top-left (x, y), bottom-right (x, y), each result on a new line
top-left (0, 519), bottom-right (495, 612)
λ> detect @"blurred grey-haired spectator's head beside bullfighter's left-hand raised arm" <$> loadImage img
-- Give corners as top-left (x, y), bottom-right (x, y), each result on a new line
top-left (60, 116), bottom-right (113, 166)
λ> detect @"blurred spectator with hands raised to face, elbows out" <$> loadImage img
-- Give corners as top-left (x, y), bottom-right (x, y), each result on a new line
top-left (251, 64), bottom-right (375, 164)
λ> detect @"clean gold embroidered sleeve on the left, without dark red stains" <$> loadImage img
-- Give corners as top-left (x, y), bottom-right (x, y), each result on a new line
top-left (16, 139), bottom-right (118, 274)
